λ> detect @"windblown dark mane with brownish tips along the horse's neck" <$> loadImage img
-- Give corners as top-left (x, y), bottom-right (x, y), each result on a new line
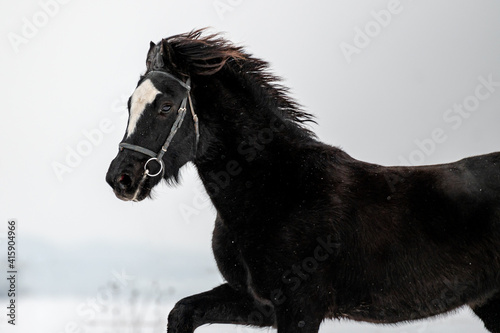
top-left (153, 29), bottom-right (314, 136)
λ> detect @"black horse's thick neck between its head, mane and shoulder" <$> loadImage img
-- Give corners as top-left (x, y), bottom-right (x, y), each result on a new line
top-left (195, 97), bottom-right (316, 223)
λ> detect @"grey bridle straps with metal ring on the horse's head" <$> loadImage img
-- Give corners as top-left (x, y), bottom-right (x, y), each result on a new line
top-left (119, 70), bottom-right (200, 201)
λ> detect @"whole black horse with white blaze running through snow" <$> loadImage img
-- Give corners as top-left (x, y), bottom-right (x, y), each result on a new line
top-left (106, 30), bottom-right (500, 333)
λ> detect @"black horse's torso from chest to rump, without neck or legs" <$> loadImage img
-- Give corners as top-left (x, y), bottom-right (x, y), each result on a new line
top-left (206, 131), bottom-right (500, 323)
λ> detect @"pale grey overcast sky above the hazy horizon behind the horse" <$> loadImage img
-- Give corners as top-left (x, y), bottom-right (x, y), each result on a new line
top-left (0, 0), bottom-right (500, 330)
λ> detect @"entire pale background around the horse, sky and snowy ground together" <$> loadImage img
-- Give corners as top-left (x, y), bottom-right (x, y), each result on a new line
top-left (0, 0), bottom-right (500, 332)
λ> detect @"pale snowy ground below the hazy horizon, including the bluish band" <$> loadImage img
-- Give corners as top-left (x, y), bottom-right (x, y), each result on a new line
top-left (0, 237), bottom-right (487, 333)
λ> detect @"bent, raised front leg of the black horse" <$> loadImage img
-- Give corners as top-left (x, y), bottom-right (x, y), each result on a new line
top-left (167, 283), bottom-right (275, 333)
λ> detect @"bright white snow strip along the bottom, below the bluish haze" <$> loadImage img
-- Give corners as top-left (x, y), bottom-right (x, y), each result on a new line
top-left (0, 295), bottom-right (487, 333)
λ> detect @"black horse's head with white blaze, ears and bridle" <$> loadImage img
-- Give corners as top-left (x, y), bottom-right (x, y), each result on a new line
top-left (106, 40), bottom-right (199, 201)
